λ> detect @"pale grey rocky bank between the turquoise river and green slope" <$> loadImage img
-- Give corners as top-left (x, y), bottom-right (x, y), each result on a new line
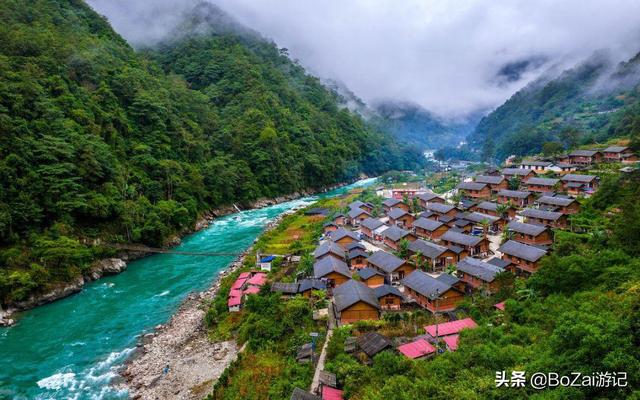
top-left (119, 212), bottom-right (296, 400)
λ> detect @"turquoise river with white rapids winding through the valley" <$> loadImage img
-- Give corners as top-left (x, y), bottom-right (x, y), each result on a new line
top-left (0, 179), bottom-right (374, 399)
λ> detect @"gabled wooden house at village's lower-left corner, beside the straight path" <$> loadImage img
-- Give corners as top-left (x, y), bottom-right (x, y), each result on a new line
top-left (333, 279), bottom-right (381, 324)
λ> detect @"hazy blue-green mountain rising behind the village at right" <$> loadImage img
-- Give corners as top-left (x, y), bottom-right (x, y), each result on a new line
top-left (469, 53), bottom-right (640, 158)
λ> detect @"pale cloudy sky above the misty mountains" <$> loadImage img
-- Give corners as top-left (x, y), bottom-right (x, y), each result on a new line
top-left (89, 0), bottom-right (640, 119)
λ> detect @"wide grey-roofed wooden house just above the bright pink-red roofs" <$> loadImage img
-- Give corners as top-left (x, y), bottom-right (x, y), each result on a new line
top-left (402, 270), bottom-right (464, 313)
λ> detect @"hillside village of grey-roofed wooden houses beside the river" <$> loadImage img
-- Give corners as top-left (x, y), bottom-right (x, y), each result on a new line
top-left (218, 146), bottom-right (637, 400)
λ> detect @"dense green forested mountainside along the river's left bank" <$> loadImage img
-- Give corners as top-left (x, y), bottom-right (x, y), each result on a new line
top-left (0, 0), bottom-right (422, 305)
